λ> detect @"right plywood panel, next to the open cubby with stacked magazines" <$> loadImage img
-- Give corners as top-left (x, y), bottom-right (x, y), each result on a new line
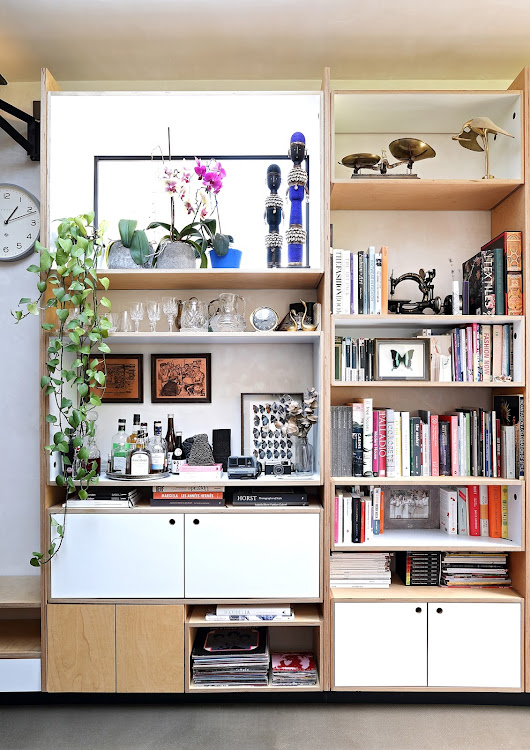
top-left (116, 604), bottom-right (184, 693)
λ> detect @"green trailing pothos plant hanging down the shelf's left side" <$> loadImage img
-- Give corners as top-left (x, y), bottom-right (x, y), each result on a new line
top-left (12, 213), bottom-right (111, 567)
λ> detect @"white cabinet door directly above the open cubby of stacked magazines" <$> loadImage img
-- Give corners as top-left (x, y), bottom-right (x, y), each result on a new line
top-left (185, 513), bottom-right (320, 599)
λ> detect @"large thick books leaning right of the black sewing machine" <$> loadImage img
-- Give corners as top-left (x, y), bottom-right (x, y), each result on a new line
top-left (462, 231), bottom-right (523, 315)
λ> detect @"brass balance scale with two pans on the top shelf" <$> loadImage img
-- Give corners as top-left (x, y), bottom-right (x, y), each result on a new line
top-left (340, 138), bottom-right (436, 179)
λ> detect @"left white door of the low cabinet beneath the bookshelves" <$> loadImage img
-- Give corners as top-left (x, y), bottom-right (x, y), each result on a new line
top-left (333, 602), bottom-right (427, 688)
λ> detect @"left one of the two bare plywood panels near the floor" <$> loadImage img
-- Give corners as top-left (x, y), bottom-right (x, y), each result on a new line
top-left (47, 604), bottom-right (116, 693)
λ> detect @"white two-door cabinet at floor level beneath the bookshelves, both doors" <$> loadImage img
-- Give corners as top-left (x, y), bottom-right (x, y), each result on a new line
top-left (333, 601), bottom-right (521, 691)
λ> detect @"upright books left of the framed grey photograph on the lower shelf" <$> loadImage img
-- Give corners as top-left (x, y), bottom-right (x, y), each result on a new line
top-left (334, 487), bottom-right (385, 545)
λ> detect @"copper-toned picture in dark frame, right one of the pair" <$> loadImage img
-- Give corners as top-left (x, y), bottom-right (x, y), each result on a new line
top-left (151, 354), bottom-right (212, 404)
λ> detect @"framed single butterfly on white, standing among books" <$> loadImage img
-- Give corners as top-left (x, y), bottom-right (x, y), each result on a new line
top-left (374, 338), bottom-right (431, 380)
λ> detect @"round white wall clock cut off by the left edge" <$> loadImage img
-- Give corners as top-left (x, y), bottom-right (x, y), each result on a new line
top-left (0, 184), bottom-right (40, 261)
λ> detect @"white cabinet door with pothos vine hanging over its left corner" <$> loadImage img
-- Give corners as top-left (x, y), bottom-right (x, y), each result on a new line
top-left (51, 512), bottom-right (184, 599)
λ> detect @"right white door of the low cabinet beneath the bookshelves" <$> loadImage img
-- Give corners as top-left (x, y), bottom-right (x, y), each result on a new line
top-left (429, 602), bottom-right (521, 690)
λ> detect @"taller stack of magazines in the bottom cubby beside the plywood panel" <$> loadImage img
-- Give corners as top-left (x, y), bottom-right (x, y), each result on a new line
top-left (191, 627), bottom-right (270, 687)
